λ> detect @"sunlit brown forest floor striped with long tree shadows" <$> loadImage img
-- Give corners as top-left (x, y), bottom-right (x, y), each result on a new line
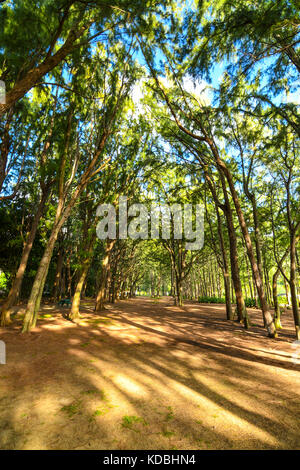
top-left (0, 297), bottom-right (300, 450)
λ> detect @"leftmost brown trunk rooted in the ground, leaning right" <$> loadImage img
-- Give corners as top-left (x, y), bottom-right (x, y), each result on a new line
top-left (0, 187), bottom-right (49, 326)
